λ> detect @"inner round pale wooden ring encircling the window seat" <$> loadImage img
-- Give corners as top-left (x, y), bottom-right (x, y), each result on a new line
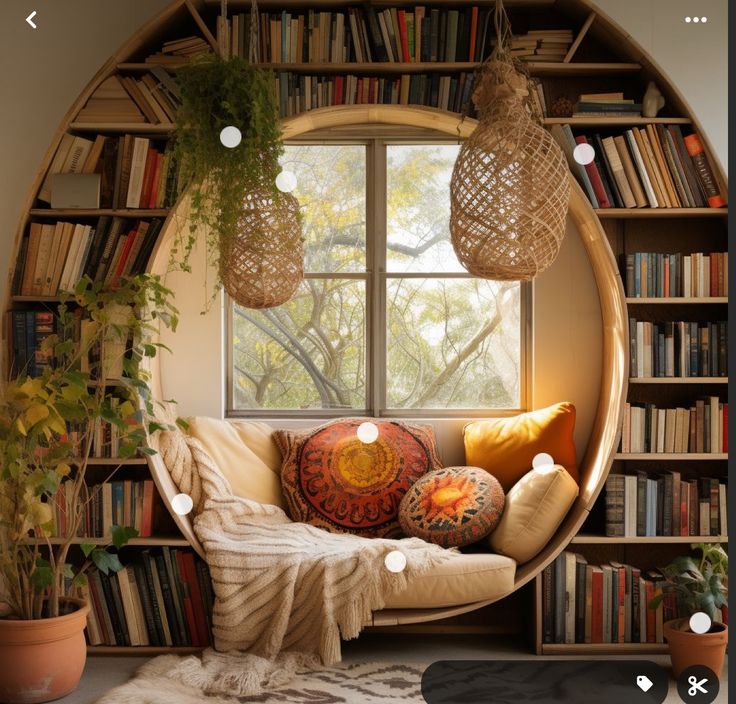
top-left (149, 105), bottom-right (628, 625)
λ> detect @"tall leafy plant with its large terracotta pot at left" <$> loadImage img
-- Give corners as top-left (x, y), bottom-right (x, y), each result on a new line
top-left (0, 275), bottom-right (177, 704)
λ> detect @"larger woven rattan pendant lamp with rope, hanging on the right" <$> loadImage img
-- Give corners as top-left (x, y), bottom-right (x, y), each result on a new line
top-left (450, 0), bottom-right (570, 281)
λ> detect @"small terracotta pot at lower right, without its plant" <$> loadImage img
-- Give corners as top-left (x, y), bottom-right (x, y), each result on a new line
top-left (664, 618), bottom-right (728, 678)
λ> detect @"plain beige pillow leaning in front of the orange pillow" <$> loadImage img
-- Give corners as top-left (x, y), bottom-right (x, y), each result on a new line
top-left (489, 464), bottom-right (578, 564)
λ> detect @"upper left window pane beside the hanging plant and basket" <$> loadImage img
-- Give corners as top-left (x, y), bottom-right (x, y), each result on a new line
top-left (281, 144), bottom-right (366, 272)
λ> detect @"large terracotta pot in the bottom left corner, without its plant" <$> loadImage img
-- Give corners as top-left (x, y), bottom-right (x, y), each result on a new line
top-left (0, 599), bottom-right (89, 704)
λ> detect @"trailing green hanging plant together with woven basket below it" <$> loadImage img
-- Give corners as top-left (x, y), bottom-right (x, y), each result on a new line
top-left (172, 56), bottom-right (303, 308)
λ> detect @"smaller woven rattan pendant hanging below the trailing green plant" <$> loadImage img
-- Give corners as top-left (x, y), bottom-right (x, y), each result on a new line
top-left (219, 0), bottom-right (304, 309)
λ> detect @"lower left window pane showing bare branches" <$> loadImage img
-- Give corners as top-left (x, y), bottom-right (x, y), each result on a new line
top-left (232, 279), bottom-right (366, 410)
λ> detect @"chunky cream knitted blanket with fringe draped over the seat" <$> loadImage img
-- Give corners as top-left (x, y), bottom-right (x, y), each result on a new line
top-left (157, 431), bottom-right (446, 665)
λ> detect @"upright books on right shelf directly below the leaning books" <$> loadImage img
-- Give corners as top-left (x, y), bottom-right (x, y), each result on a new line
top-left (623, 252), bottom-right (728, 298)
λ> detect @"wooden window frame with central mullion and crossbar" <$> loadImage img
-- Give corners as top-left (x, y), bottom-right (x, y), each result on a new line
top-left (224, 132), bottom-right (533, 420)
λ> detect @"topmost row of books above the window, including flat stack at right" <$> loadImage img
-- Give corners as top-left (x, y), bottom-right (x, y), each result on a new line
top-left (217, 5), bottom-right (524, 64)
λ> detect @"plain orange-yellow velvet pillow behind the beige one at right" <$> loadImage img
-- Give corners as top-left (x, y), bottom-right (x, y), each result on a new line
top-left (463, 401), bottom-right (579, 491)
